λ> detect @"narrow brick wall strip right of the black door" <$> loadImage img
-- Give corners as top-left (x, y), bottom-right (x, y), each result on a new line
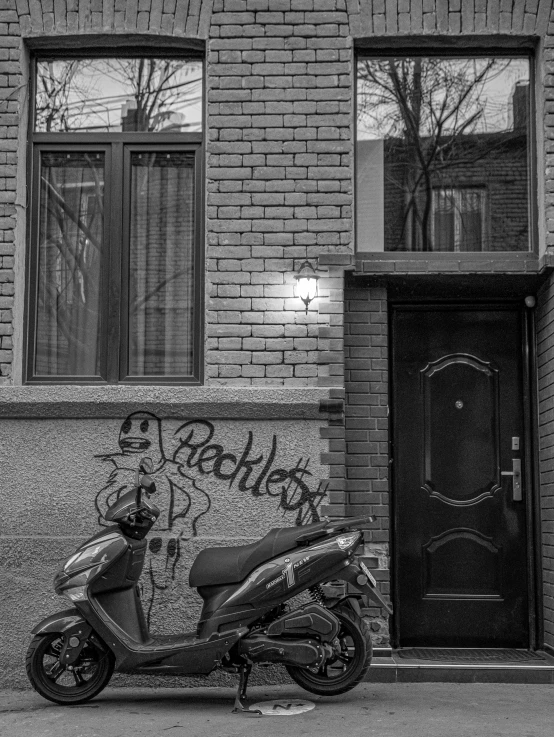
top-left (536, 276), bottom-right (554, 647)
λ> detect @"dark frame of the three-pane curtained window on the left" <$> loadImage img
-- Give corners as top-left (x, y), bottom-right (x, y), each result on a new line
top-left (23, 48), bottom-right (206, 386)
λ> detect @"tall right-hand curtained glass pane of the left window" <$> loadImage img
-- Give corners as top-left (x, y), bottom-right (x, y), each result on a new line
top-left (129, 151), bottom-right (195, 376)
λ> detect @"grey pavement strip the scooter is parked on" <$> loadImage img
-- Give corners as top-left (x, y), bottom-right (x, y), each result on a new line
top-left (0, 683), bottom-right (554, 737)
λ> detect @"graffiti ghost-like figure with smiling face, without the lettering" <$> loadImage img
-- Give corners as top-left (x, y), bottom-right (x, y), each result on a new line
top-left (95, 412), bottom-right (211, 624)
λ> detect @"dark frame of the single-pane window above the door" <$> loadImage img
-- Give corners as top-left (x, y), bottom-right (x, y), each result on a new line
top-left (352, 46), bottom-right (539, 256)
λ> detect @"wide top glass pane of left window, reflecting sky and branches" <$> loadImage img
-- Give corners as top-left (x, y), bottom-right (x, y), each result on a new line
top-left (35, 58), bottom-right (202, 133)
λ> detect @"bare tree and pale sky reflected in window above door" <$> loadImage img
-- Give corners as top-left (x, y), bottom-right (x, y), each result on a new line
top-left (358, 57), bottom-right (525, 251)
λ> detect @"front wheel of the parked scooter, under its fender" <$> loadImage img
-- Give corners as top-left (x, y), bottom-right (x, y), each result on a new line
top-left (26, 632), bottom-right (114, 704)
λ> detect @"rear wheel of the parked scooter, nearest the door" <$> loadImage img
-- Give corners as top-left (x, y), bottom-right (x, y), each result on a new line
top-left (285, 605), bottom-right (373, 696)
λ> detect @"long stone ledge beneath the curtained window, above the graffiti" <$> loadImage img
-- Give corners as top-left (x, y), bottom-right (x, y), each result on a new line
top-left (0, 385), bottom-right (329, 420)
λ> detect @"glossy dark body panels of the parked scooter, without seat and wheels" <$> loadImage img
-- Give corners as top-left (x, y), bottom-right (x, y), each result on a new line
top-left (47, 508), bottom-right (374, 675)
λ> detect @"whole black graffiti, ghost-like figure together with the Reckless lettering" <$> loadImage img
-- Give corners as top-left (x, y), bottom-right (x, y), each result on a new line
top-left (95, 412), bottom-right (325, 625)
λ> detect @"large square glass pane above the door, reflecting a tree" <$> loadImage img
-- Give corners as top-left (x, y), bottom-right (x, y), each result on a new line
top-left (356, 55), bottom-right (530, 252)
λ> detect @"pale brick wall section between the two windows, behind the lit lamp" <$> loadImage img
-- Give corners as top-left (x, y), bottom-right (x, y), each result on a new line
top-left (207, 0), bottom-right (352, 386)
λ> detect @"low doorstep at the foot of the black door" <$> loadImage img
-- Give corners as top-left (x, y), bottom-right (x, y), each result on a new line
top-left (366, 648), bottom-right (554, 683)
